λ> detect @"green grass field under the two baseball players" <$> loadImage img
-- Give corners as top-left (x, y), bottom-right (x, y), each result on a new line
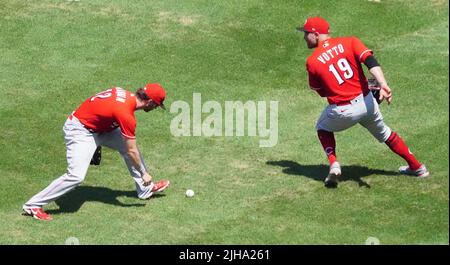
top-left (0, 0), bottom-right (449, 244)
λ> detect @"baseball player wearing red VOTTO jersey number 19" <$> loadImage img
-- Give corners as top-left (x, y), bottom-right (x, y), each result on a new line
top-left (297, 17), bottom-right (430, 187)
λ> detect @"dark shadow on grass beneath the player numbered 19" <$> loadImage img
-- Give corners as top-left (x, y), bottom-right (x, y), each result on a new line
top-left (266, 160), bottom-right (400, 188)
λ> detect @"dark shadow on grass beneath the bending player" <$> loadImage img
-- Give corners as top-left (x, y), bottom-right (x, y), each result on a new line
top-left (46, 186), bottom-right (165, 214)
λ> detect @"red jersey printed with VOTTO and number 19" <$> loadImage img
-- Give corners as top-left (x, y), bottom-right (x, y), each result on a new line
top-left (306, 37), bottom-right (373, 104)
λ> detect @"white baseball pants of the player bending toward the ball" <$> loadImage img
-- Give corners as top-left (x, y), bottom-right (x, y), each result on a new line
top-left (23, 115), bottom-right (153, 208)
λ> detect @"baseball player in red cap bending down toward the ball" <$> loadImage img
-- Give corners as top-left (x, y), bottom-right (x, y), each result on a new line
top-left (23, 83), bottom-right (170, 221)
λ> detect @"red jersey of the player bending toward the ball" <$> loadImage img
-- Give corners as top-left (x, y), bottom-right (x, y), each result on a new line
top-left (73, 87), bottom-right (136, 139)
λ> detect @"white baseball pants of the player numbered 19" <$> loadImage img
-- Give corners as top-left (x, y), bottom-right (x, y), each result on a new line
top-left (316, 92), bottom-right (392, 142)
